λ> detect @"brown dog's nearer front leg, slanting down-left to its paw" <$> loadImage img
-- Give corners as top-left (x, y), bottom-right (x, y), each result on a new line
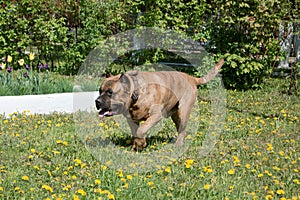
top-left (132, 105), bottom-right (162, 150)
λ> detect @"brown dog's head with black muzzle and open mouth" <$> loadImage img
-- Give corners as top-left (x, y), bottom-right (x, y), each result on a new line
top-left (95, 75), bottom-right (130, 118)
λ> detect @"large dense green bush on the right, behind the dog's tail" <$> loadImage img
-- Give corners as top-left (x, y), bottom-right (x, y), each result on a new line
top-left (208, 0), bottom-right (299, 89)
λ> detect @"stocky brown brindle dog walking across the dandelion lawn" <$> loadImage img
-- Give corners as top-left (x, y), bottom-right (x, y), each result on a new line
top-left (95, 59), bottom-right (224, 150)
